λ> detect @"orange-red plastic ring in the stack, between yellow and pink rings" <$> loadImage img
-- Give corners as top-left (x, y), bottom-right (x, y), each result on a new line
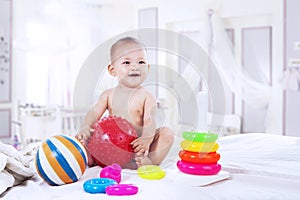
top-left (178, 150), bottom-right (220, 164)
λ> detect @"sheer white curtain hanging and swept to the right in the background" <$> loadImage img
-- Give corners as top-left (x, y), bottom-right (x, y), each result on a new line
top-left (208, 10), bottom-right (271, 107)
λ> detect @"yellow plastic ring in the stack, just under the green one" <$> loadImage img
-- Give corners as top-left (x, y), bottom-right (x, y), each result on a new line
top-left (180, 140), bottom-right (219, 152)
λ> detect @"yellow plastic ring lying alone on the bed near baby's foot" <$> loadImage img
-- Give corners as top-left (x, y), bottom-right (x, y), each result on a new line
top-left (137, 165), bottom-right (166, 180)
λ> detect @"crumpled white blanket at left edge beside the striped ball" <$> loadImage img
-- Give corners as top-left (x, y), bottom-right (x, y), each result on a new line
top-left (0, 141), bottom-right (39, 195)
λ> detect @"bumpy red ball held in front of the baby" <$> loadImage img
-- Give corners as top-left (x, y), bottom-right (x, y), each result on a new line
top-left (88, 116), bottom-right (137, 167)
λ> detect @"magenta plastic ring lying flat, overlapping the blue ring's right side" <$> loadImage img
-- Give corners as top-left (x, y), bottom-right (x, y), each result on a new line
top-left (105, 184), bottom-right (139, 196)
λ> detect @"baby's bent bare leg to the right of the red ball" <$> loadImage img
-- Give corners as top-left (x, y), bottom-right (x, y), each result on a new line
top-left (137, 127), bottom-right (174, 166)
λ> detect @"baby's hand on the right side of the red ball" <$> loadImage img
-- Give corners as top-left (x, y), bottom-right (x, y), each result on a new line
top-left (131, 137), bottom-right (153, 156)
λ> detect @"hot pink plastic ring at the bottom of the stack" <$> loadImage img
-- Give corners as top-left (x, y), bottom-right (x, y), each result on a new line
top-left (177, 160), bottom-right (221, 175)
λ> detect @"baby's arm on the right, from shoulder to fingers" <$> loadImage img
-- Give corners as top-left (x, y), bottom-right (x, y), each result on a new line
top-left (131, 94), bottom-right (156, 156)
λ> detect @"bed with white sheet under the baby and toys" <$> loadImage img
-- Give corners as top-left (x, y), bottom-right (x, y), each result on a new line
top-left (0, 133), bottom-right (300, 200)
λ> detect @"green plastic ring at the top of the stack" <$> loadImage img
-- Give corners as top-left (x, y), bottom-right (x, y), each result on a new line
top-left (182, 131), bottom-right (218, 142)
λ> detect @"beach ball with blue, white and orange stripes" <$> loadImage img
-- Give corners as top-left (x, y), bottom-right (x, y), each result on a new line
top-left (35, 135), bottom-right (87, 185)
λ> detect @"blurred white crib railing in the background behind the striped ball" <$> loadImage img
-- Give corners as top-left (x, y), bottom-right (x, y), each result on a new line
top-left (19, 106), bottom-right (86, 145)
